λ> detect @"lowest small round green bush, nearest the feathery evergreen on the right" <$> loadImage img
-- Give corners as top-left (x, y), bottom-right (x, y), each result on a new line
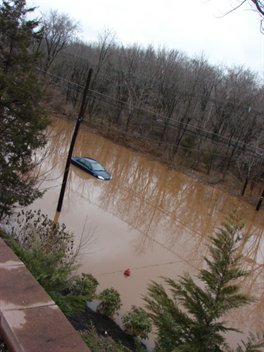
top-left (122, 306), bottom-right (151, 339)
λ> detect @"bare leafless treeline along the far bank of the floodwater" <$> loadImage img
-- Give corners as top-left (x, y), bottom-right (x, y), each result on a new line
top-left (38, 21), bottom-right (264, 193)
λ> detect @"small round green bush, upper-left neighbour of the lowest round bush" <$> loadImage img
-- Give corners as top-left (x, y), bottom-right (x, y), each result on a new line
top-left (97, 288), bottom-right (122, 318)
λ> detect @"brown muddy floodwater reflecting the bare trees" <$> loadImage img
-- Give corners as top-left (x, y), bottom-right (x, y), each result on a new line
top-left (29, 119), bottom-right (264, 348)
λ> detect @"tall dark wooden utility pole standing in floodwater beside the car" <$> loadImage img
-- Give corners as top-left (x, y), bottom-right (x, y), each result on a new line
top-left (57, 68), bottom-right (93, 212)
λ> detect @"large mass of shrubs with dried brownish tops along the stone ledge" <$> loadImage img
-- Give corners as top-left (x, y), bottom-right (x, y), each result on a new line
top-left (2, 210), bottom-right (98, 316)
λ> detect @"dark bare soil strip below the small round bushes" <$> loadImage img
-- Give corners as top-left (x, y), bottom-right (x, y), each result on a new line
top-left (70, 307), bottom-right (147, 352)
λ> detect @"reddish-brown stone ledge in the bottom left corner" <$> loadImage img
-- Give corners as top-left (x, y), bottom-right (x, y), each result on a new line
top-left (0, 239), bottom-right (90, 352)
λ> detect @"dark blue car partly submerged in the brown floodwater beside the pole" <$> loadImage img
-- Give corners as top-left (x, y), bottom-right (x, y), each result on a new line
top-left (71, 156), bottom-right (112, 180)
